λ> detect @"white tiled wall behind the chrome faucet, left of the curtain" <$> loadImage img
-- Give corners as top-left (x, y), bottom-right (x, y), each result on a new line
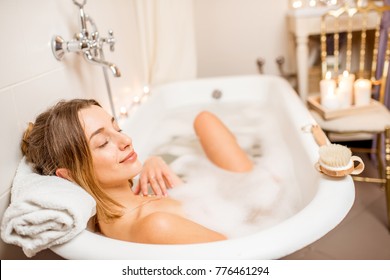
top-left (0, 0), bottom-right (144, 259)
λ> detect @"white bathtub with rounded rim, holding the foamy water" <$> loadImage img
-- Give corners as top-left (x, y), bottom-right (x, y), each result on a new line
top-left (52, 76), bottom-right (355, 259)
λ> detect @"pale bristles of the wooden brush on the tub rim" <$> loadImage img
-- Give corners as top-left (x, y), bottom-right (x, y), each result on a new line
top-left (319, 144), bottom-right (352, 167)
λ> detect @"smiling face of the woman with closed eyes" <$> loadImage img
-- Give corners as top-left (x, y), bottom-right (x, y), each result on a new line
top-left (79, 105), bottom-right (142, 187)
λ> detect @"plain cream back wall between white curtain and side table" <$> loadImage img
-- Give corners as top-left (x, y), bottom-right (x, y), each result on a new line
top-left (194, 0), bottom-right (291, 77)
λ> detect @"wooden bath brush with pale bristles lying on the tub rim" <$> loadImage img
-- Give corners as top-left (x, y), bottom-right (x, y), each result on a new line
top-left (311, 125), bottom-right (364, 177)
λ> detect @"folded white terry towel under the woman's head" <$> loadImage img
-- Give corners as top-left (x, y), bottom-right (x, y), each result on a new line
top-left (1, 158), bottom-right (96, 257)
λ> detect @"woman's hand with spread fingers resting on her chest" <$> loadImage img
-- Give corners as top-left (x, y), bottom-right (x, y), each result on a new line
top-left (134, 156), bottom-right (182, 196)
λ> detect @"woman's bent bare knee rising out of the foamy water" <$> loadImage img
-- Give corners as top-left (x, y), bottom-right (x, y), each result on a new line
top-left (194, 111), bottom-right (253, 172)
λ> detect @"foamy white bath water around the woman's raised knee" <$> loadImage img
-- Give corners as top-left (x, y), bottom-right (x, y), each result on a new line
top-left (145, 103), bottom-right (301, 238)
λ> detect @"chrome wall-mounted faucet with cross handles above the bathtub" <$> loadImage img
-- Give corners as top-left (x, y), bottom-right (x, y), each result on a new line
top-left (52, 0), bottom-right (121, 77)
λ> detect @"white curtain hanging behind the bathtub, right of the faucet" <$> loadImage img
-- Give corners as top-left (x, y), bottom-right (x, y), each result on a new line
top-left (135, 0), bottom-right (196, 85)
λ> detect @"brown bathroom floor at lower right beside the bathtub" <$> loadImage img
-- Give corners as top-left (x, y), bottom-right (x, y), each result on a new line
top-left (282, 151), bottom-right (390, 260)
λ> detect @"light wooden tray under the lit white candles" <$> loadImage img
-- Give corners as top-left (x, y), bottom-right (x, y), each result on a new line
top-left (307, 95), bottom-right (381, 120)
